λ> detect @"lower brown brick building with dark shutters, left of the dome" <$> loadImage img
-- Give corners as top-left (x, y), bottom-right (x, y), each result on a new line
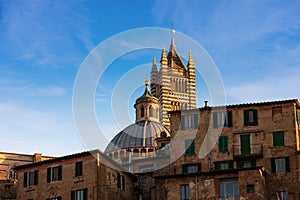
top-left (15, 150), bottom-right (135, 200)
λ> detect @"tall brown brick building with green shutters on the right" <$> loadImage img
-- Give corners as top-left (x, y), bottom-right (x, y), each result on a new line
top-left (153, 100), bottom-right (300, 200)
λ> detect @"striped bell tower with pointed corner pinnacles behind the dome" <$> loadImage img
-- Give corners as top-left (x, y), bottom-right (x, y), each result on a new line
top-left (150, 37), bottom-right (196, 128)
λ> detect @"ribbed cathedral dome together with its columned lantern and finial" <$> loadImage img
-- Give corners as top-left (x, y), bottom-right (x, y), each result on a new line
top-left (105, 79), bottom-right (171, 158)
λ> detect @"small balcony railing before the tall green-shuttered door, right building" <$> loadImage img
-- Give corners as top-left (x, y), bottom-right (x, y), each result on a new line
top-left (233, 144), bottom-right (263, 159)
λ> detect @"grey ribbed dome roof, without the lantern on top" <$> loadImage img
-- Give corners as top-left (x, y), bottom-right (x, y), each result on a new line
top-left (105, 121), bottom-right (170, 153)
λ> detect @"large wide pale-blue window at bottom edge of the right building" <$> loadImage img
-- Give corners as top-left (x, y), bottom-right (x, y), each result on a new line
top-left (220, 179), bottom-right (239, 200)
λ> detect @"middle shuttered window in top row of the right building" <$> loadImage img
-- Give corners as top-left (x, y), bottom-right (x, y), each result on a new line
top-left (213, 110), bottom-right (232, 128)
